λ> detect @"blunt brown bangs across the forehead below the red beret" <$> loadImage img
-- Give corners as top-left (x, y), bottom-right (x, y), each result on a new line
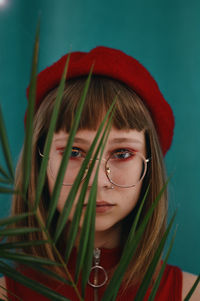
top-left (38, 76), bottom-right (152, 132)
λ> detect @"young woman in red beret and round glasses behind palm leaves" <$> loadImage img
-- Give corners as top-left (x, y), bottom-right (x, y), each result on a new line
top-left (1, 47), bottom-right (200, 301)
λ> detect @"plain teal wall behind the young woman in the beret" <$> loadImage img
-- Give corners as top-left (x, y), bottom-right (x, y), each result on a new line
top-left (0, 0), bottom-right (200, 273)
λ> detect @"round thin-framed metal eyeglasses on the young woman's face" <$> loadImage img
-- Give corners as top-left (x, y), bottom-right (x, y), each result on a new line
top-left (39, 147), bottom-right (150, 188)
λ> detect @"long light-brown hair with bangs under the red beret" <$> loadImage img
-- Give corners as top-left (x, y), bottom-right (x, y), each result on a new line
top-left (12, 76), bottom-right (167, 285)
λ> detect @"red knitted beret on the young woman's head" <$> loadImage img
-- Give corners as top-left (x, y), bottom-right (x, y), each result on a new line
top-left (27, 47), bottom-right (174, 155)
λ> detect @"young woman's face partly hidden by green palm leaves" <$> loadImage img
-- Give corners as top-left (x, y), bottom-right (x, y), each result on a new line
top-left (47, 128), bottom-right (146, 231)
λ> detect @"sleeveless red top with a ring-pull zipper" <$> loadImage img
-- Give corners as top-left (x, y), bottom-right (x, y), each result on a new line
top-left (5, 249), bottom-right (182, 301)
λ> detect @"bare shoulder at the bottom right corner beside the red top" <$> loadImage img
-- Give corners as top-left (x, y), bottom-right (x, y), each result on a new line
top-left (182, 272), bottom-right (200, 301)
